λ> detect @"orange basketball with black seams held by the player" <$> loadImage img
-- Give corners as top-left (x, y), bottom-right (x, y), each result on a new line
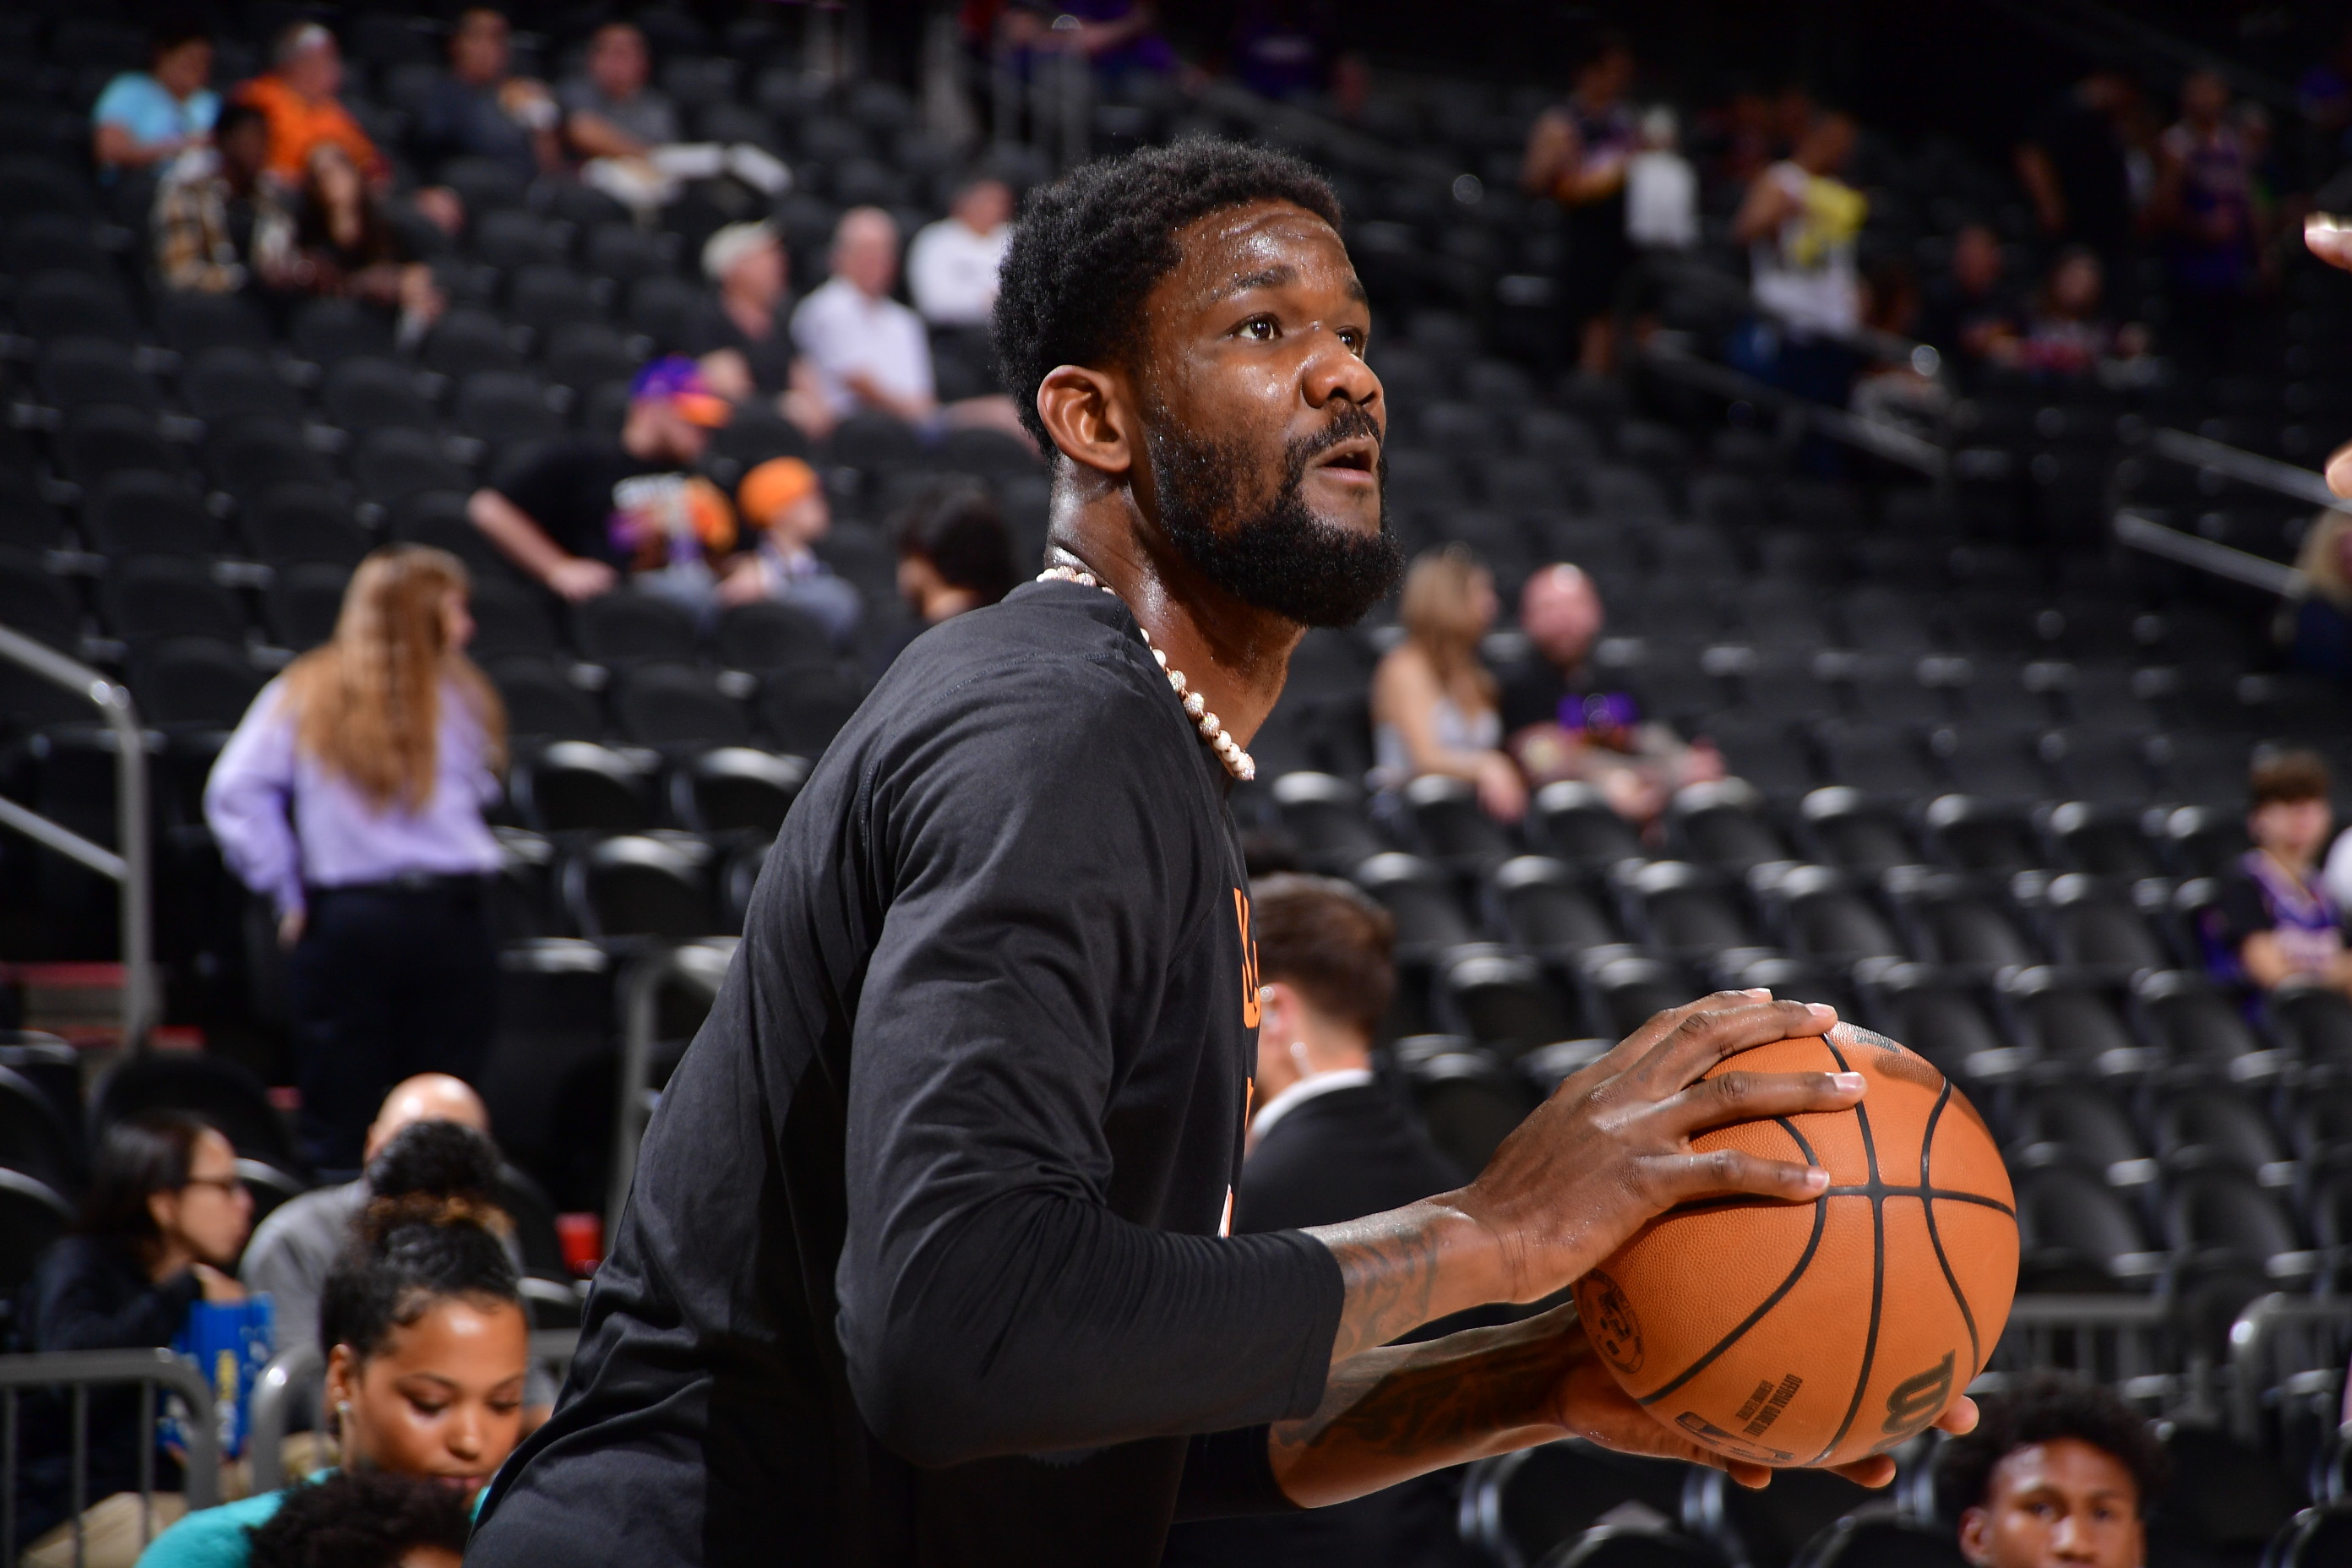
top-left (1576, 1025), bottom-right (2018, 1465)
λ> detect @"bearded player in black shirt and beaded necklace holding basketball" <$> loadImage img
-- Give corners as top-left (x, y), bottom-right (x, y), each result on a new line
top-left (471, 141), bottom-right (1974, 1568)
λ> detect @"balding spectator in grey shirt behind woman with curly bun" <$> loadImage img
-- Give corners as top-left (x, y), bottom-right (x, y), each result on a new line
top-left (237, 1072), bottom-right (491, 1352)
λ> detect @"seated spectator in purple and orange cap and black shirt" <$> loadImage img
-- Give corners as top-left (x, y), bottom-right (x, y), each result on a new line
top-left (466, 355), bottom-right (734, 600)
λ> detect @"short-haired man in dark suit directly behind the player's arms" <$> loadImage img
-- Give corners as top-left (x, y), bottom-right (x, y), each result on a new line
top-left (1162, 874), bottom-right (1463, 1568)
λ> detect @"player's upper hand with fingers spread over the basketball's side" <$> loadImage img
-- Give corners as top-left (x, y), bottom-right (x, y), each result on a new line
top-left (1458, 989), bottom-right (1863, 1303)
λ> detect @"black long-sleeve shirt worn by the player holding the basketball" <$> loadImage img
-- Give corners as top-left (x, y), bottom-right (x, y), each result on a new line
top-left (468, 583), bottom-right (1341, 1568)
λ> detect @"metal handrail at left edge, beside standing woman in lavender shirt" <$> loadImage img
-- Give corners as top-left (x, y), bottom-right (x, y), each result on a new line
top-left (0, 625), bottom-right (155, 1051)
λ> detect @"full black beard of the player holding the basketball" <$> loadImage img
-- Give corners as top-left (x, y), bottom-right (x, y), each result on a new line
top-left (1143, 406), bottom-right (1404, 625)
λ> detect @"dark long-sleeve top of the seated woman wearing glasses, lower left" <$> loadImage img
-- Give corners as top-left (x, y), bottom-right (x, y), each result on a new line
top-left (12, 1237), bottom-right (200, 1556)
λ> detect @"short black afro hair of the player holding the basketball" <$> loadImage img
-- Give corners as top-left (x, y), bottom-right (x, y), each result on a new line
top-left (990, 136), bottom-right (1341, 456)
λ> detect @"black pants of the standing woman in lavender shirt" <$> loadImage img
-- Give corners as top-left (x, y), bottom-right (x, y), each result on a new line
top-left (287, 879), bottom-right (498, 1171)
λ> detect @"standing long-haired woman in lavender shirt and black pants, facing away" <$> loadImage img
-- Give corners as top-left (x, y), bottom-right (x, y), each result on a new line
top-left (204, 546), bottom-right (506, 1171)
